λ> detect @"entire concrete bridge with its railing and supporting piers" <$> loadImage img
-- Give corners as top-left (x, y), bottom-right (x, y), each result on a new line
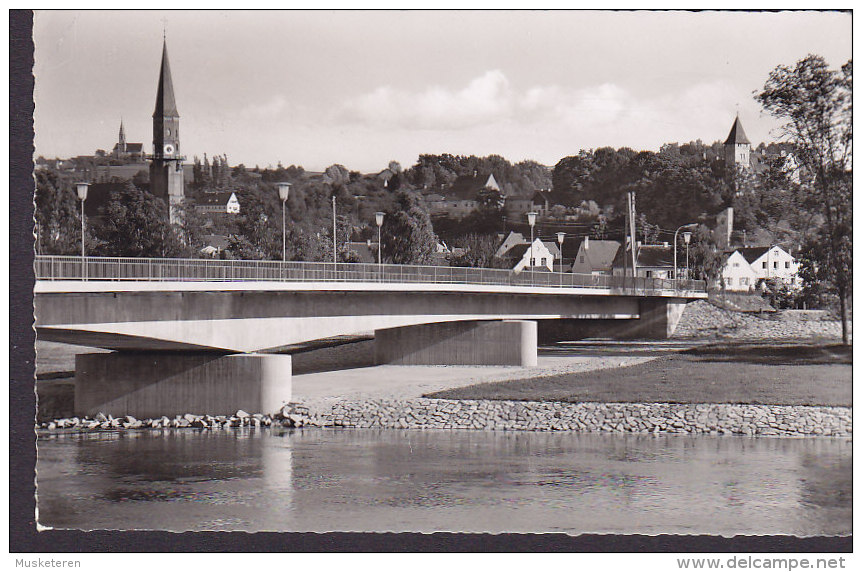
top-left (34, 256), bottom-right (706, 417)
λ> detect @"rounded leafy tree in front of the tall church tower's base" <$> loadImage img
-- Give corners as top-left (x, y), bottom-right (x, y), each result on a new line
top-left (96, 182), bottom-right (187, 258)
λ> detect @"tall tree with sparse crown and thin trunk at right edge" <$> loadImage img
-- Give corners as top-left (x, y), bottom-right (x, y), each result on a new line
top-left (755, 55), bottom-right (853, 344)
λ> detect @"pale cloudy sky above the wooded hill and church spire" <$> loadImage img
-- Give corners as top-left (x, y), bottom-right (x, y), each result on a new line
top-left (34, 11), bottom-right (851, 171)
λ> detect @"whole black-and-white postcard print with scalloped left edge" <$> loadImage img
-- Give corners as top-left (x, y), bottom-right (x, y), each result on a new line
top-left (22, 9), bottom-right (853, 538)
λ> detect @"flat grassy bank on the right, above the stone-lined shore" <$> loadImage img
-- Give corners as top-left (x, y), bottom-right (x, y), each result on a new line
top-left (427, 343), bottom-right (852, 406)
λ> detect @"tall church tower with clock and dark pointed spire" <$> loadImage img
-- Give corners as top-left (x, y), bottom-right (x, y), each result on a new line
top-left (150, 40), bottom-right (185, 223)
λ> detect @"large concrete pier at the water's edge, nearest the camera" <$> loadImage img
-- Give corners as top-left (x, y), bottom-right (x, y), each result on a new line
top-left (75, 352), bottom-right (291, 418)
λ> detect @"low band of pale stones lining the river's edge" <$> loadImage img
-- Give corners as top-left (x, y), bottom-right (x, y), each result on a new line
top-left (35, 398), bottom-right (853, 437)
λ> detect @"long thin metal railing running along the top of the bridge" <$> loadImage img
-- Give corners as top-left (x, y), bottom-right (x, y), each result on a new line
top-left (34, 255), bottom-right (706, 294)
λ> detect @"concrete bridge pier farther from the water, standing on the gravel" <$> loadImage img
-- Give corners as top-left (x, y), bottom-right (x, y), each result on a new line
top-left (374, 320), bottom-right (538, 366)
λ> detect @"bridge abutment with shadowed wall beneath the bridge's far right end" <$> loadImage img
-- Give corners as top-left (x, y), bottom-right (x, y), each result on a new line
top-left (539, 298), bottom-right (687, 344)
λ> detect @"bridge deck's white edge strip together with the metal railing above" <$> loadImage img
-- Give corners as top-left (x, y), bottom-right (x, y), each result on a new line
top-left (34, 256), bottom-right (706, 298)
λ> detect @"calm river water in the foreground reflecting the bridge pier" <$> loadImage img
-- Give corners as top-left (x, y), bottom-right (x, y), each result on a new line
top-left (37, 429), bottom-right (852, 536)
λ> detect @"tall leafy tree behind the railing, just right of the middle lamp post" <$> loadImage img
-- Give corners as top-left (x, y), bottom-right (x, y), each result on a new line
top-left (381, 191), bottom-right (437, 264)
